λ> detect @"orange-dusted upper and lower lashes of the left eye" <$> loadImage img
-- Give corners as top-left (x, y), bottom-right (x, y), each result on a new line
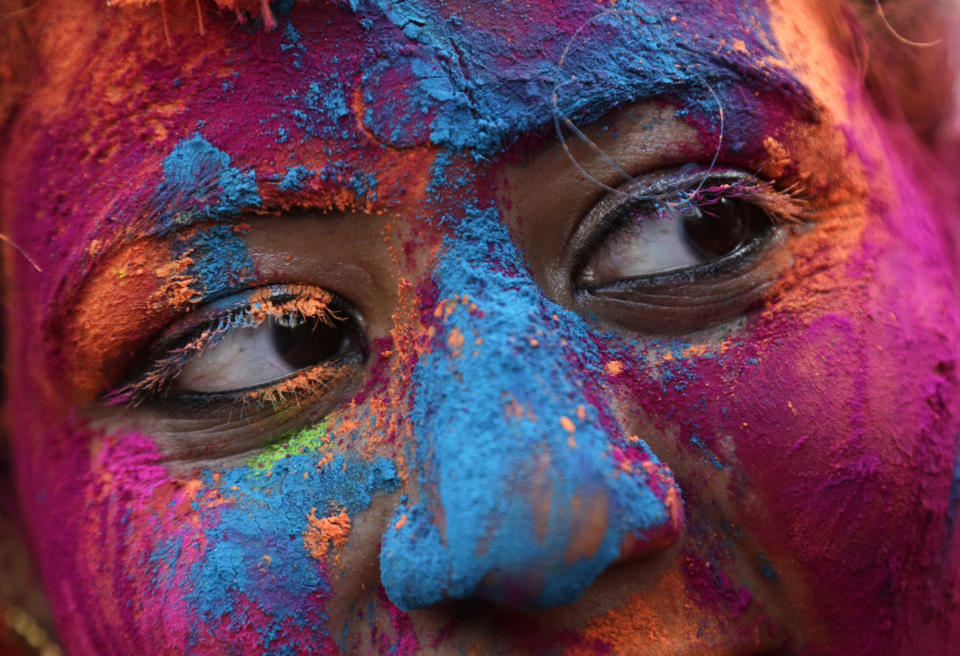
top-left (104, 285), bottom-right (353, 412)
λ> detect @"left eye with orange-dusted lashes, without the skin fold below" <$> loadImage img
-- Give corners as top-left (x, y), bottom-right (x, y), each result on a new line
top-left (107, 285), bottom-right (366, 412)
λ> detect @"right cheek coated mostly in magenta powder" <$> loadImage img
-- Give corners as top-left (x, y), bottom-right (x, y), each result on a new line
top-left (606, 213), bottom-right (958, 640)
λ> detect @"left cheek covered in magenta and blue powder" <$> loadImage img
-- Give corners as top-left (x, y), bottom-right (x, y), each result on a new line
top-left (15, 410), bottom-right (399, 655)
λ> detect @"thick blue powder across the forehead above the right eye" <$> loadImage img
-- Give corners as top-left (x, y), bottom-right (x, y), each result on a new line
top-left (350, 0), bottom-right (804, 155)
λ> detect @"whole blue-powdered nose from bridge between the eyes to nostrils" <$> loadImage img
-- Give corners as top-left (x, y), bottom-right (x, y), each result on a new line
top-left (380, 212), bottom-right (683, 610)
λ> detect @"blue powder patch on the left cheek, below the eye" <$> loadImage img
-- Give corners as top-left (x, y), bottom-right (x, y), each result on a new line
top-left (172, 453), bottom-right (399, 655)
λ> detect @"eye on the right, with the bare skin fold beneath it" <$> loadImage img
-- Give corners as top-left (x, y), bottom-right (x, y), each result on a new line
top-left (573, 166), bottom-right (806, 334)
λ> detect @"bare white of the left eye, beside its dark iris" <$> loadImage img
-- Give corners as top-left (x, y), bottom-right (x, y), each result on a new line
top-left (174, 319), bottom-right (297, 394)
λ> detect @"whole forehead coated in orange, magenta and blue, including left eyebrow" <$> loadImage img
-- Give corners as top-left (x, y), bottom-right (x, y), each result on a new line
top-left (5, 0), bottom-right (803, 294)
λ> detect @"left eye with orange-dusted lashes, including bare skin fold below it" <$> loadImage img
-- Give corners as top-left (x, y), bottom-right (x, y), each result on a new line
top-left (105, 285), bottom-right (367, 459)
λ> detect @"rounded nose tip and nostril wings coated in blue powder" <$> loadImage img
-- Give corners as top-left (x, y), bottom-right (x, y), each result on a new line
top-left (380, 426), bottom-right (683, 610)
